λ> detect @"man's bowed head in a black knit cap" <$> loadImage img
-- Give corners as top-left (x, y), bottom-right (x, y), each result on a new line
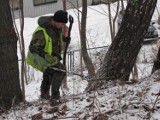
top-left (52, 10), bottom-right (68, 29)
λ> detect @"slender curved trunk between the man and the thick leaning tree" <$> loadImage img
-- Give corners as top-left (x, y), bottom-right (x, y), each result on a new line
top-left (80, 0), bottom-right (95, 78)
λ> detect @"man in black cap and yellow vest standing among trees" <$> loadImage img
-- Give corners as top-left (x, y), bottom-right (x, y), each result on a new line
top-left (27, 10), bottom-right (70, 106)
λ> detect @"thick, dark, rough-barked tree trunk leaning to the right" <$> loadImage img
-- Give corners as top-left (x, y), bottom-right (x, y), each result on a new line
top-left (87, 0), bottom-right (157, 90)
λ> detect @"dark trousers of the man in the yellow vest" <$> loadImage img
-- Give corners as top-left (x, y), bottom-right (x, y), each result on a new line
top-left (41, 64), bottom-right (66, 99)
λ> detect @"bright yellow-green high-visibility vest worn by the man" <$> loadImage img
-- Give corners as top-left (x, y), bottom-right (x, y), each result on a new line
top-left (26, 26), bottom-right (54, 72)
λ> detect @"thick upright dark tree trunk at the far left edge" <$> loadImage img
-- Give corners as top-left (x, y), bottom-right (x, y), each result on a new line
top-left (0, 0), bottom-right (23, 109)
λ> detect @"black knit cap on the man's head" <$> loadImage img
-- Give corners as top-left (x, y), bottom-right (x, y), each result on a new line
top-left (52, 10), bottom-right (68, 23)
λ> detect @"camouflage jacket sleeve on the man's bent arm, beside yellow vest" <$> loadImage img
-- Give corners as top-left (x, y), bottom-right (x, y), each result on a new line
top-left (29, 31), bottom-right (46, 58)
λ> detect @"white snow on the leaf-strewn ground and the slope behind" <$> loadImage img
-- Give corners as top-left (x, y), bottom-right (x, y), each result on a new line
top-left (0, 0), bottom-right (160, 120)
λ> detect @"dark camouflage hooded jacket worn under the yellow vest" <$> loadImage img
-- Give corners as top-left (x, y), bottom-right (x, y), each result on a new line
top-left (29, 16), bottom-right (64, 60)
